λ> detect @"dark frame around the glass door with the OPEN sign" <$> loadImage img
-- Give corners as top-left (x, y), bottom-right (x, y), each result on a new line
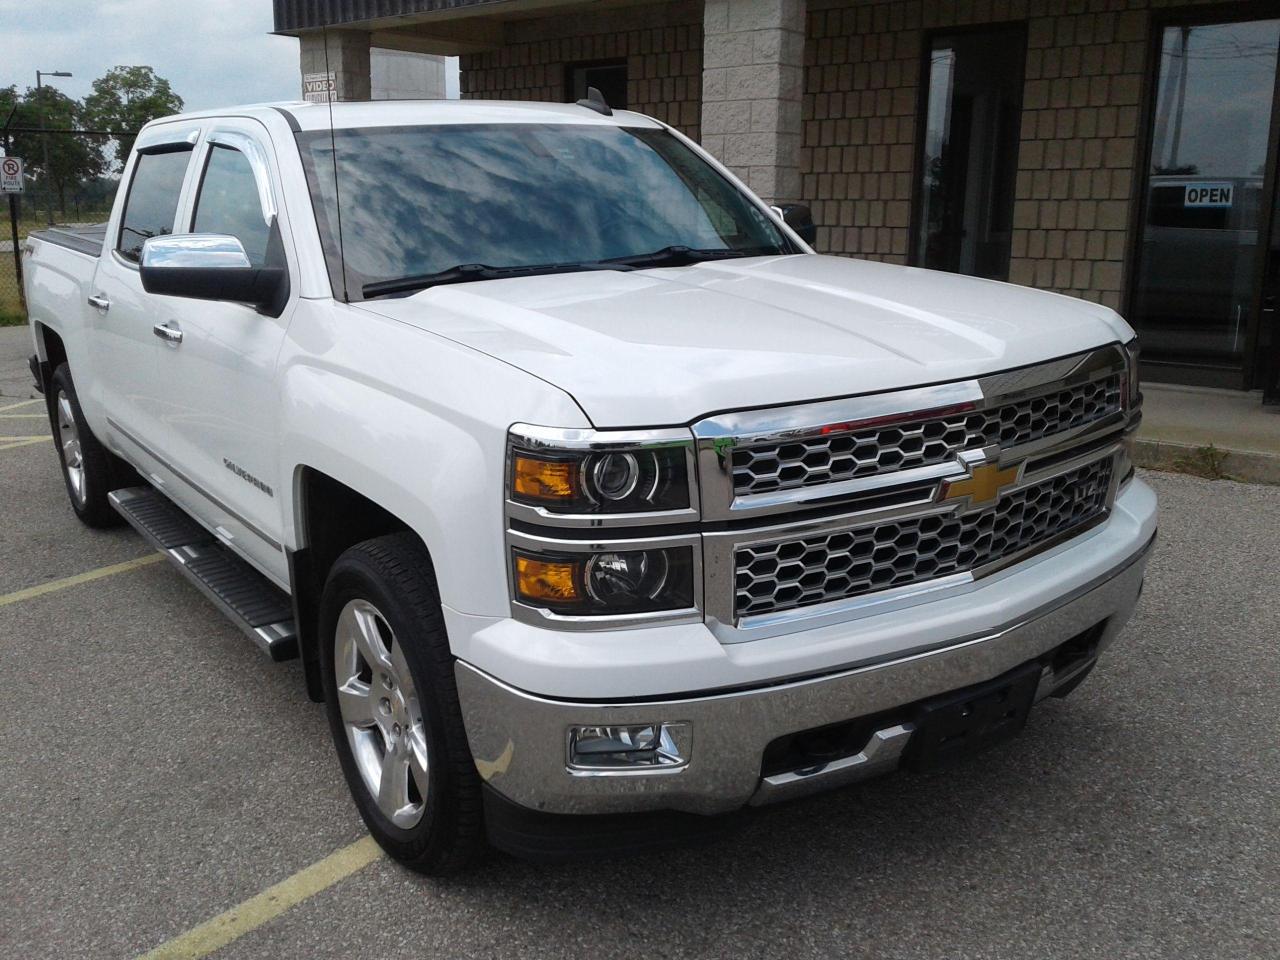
top-left (1123, 0), bottom-right (1280, 390)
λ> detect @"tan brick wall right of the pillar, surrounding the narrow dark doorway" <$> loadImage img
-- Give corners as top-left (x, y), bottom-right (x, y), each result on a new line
top-left (800, 0), bottom-right (1203, 307)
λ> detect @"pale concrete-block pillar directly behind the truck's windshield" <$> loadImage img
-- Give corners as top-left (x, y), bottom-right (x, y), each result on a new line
top-left (701, 0), bottom-right (805, 204)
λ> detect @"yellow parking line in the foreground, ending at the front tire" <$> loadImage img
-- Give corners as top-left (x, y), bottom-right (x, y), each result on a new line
top-left (138, 837), bottom-right (381, 960)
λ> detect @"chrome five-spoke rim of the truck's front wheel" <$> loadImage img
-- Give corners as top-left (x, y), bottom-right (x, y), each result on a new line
top-left (334, 600), bottom-right (430, 829)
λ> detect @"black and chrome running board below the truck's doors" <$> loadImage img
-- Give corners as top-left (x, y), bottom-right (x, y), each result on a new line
top-left (108, 486), bottom-right (298, 660)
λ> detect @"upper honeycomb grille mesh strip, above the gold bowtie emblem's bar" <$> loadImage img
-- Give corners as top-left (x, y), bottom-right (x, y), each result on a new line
top-left (731, 372), bottom-right (1124, 497)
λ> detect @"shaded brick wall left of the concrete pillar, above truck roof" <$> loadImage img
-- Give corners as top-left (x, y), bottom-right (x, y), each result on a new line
top-left (461, 0), bottom-right (703, 138)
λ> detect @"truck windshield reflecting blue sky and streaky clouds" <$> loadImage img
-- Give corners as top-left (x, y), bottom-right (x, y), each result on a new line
top-left (298, 124), bottom-right (796, 300)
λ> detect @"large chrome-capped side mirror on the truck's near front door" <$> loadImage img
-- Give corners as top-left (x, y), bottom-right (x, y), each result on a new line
top-left (138, 233), bottom-right (289, 316)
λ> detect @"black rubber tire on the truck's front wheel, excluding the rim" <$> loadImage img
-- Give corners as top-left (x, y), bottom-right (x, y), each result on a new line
top-left (319, 532), bottom-right (484, 876)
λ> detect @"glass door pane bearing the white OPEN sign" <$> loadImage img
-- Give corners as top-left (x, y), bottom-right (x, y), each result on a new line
top-left (1129, 19), bottom-right (1280, 387)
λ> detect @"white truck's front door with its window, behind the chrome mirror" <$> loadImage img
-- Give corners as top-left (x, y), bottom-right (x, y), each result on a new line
top-left (146, 119), bottom-right (298, 585)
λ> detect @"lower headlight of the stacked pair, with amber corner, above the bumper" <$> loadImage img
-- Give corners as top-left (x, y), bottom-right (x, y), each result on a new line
top-left (512, 547), bottom-right (694, 616)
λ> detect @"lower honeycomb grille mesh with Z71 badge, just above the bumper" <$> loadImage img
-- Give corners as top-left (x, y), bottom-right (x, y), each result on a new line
top-left (733, 457), bottom-right (1114, 617)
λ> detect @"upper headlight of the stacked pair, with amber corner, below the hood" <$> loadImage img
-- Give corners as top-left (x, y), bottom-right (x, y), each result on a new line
top-left (507, 426), bottom-right (692, 516)
